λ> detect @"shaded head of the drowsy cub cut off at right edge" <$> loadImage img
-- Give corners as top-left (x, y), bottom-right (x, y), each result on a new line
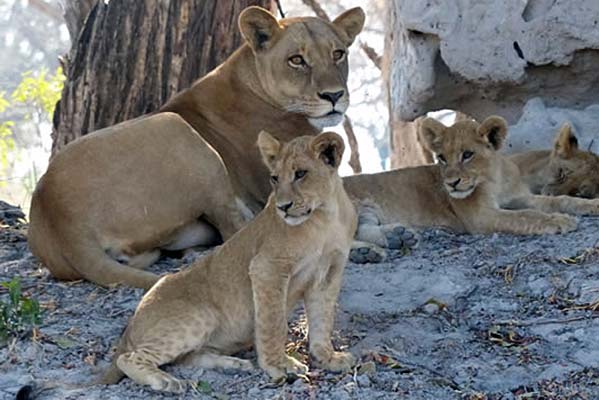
top-left (542, 123), bottom-right (599, 199)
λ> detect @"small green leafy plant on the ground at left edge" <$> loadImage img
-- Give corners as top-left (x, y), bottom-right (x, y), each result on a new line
top-left (0, 277), bottom-right (42, 343)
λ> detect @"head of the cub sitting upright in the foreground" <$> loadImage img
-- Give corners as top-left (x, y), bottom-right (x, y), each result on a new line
top-left (258, 131), bottom-right (344, 225)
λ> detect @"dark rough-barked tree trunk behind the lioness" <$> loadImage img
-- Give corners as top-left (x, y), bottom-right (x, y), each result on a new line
top-left (52, 0), bottom-right (272, 155)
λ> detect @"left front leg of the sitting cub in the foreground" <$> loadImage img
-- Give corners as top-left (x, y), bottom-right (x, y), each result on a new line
top-left (250, 256), bottom-right (308, 381)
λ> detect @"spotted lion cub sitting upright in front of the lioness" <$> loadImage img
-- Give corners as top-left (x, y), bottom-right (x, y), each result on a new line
top-left (104, 132), bottom-right (357, 392)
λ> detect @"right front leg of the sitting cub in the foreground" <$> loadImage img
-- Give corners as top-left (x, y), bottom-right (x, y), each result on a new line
top-left (304, 254), bottom-right (356, 372)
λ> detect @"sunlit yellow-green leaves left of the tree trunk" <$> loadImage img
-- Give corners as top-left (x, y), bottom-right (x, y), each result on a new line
top-left (11, 67), bottom-right (65, 116)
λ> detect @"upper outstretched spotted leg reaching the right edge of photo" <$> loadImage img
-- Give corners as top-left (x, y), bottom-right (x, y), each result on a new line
top-left (509, 195), bottom-right (599, 215)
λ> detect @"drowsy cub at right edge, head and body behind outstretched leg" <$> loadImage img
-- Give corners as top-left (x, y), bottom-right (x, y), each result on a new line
top-left (510, 123), bottom-right (599, 199)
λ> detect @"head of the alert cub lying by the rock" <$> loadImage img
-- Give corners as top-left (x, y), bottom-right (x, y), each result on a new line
top-left (420, 116), bottom-right (507, 199)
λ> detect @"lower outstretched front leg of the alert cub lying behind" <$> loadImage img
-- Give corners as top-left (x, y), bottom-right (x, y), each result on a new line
top-left (469, 209), bottom-right (577, 235)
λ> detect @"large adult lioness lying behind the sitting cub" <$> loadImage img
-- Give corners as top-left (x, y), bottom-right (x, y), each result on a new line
top-left (29, 7), bottom-right (364, 288)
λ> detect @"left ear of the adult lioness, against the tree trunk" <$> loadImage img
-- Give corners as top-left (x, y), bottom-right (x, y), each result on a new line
top-left (239, 6), bottom-right (281, 52)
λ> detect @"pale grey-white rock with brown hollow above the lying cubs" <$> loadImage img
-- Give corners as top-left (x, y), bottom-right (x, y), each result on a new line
top-left (387, 0), bottom-right (599, 122)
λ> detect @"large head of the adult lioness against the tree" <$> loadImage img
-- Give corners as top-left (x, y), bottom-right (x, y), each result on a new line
top-left (239, 7), bottom-right (365, 129)
